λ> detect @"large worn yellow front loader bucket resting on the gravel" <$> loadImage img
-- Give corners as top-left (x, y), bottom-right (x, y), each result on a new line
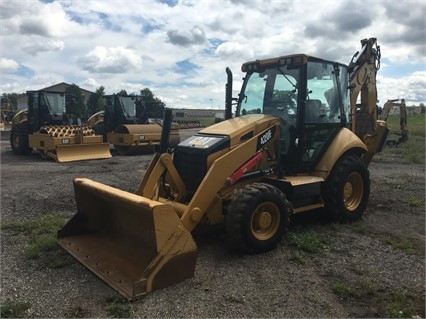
top-left (58, 178), bottom-right (198, 299)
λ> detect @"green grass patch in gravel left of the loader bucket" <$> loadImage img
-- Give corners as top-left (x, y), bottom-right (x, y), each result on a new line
top-left (0, 214), bottom-right (65, 258)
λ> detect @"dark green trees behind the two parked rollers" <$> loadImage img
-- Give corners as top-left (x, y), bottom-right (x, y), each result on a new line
top-left (1, 84), bottom-right (166, 118)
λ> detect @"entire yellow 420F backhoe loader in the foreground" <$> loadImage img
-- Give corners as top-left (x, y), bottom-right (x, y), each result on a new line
top-left (58, 38), bottom-right (387, 299)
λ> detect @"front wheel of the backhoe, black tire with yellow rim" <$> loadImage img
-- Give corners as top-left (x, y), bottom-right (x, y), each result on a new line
top-left (225, 183), bottom-right (289, 253)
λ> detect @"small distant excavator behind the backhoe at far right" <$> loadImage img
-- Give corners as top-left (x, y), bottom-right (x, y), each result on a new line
top-left (379, 99), bottom-right (408, 146)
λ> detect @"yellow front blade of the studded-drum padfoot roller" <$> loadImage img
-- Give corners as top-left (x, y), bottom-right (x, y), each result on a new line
top-left (56, 143), bottom-right (112, 163)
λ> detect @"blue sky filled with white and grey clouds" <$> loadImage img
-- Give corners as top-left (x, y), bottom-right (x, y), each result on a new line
top-left (0, 0), bottom-right (426, 109)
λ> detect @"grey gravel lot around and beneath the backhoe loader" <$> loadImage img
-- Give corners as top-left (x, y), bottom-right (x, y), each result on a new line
top-left (0, 132), bottom-right (425, 318)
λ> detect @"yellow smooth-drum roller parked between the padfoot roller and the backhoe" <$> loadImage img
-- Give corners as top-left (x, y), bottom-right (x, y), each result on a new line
top-left (88, 94), bottom-right (180, 155)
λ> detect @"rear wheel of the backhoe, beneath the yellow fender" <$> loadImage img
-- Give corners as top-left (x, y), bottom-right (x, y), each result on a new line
top-left (323, 156), bottom-right (370, 222)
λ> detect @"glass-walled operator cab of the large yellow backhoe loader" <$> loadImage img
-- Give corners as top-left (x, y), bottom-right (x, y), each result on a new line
top-left (236, 54), bottom-right (350, 172)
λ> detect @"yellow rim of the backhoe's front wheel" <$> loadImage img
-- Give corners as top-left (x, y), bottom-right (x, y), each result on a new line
top-left (251, 203), bottom-right (280, 240)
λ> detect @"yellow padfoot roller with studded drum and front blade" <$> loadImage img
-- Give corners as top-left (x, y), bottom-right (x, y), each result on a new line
top-left (10, 91), bottom-right (111, 162)
